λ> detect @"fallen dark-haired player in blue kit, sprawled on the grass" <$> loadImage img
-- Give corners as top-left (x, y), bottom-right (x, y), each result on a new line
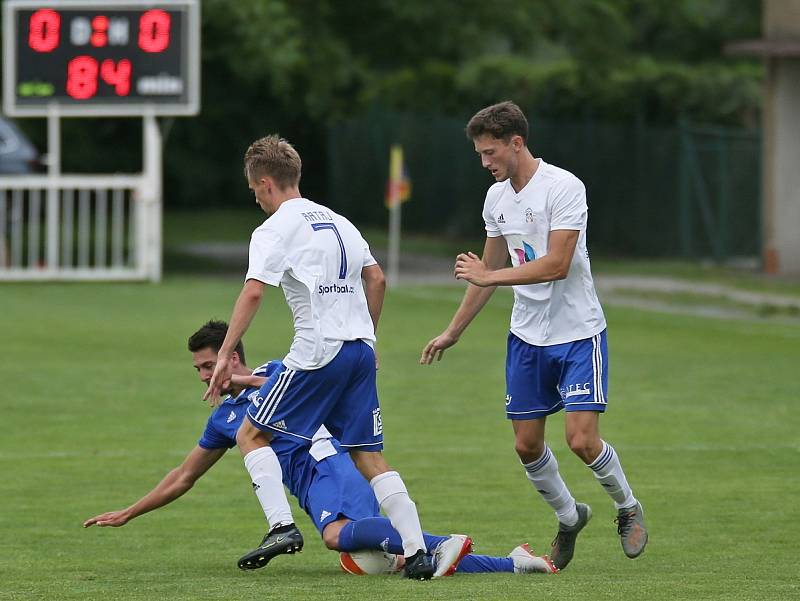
top-left (83, 321), bottom-right (557, 577)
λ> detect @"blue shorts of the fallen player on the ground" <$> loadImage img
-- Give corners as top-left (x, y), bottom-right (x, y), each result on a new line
top-left (303, 453), bottom-right (380, 534)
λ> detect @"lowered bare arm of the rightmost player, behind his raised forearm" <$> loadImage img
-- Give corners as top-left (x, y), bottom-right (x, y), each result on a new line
top-left (419, 236), bottom-right (508, 365)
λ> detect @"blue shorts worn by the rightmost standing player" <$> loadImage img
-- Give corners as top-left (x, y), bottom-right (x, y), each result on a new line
top-left (506, 330), bottom-right (608, 419)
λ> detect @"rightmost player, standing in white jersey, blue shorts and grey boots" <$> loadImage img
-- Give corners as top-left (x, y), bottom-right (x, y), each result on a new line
top-left (420, 102), bottom-right (647, 569)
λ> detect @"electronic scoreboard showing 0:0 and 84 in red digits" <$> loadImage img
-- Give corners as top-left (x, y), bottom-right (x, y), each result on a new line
top-left (3, 0), bottom-right (200, 116)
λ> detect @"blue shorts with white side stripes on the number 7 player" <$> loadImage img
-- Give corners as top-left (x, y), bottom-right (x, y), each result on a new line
top-left (247, 340), bottom-right (383, 451)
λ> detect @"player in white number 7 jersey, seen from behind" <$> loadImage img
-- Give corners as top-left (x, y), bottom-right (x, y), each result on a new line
top-left (206, 135), bottom-right (434, 580)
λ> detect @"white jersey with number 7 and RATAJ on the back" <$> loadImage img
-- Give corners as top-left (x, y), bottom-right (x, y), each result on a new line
top-left (245, 198), bottom-right (377, 370)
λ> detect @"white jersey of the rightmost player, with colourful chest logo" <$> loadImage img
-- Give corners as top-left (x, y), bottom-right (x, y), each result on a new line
top-left (483, 159), bottom-right (606, 346)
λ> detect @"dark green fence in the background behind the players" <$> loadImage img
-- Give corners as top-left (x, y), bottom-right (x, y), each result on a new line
top-left (328, 112), bottom-right (761, 261)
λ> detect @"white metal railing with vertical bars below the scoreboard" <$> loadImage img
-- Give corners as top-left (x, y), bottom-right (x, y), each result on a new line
top-left (0, 175), bottom-right (161, 281)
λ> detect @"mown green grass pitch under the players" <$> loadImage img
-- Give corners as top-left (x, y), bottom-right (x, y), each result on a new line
top-left (0, 278), bottom-right (800, 601)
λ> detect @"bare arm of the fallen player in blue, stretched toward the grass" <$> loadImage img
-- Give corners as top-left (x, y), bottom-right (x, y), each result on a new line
top-left (83, 445), bottom-right (227, 528)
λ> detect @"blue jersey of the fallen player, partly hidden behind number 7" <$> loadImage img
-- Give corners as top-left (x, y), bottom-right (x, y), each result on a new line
top-left (198, 361), bottom-right (346, 508)
